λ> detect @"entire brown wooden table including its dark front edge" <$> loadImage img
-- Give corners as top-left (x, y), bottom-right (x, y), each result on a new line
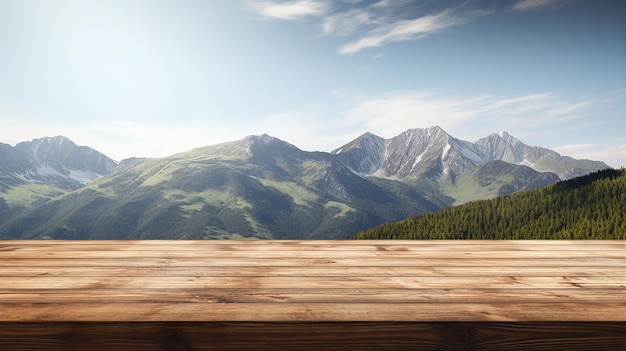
top-left (0, 241), bottom-right (626, 350)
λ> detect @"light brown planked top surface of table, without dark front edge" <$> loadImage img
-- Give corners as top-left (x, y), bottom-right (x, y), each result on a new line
top-left (0, 241), bottom-right (626, 322)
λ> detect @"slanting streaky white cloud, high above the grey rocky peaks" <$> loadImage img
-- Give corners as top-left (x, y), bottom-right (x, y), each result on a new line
top-left (339, 10), bottom-right (470, 54)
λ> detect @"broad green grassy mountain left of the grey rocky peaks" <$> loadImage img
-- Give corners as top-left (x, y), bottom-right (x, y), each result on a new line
top-left (0, 136), bottom-right (449, 239)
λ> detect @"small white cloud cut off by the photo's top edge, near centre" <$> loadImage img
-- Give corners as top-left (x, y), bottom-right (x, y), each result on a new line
top-left (249, 0), bottom-right (328, 20)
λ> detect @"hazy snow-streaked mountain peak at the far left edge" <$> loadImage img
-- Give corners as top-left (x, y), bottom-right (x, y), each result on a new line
top-left (0, 136), bottom-right (116, 189)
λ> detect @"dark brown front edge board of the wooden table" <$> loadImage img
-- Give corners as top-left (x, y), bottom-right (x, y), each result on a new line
top-left (0, 322), bottom-right (626, 351)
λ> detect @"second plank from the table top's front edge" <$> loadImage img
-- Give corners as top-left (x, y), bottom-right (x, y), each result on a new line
top-left (0, 288), bottom-right (626, 305)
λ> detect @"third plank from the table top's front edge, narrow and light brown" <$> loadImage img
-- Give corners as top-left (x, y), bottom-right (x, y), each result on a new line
top-left (0, 273), bottom-right (626, 290)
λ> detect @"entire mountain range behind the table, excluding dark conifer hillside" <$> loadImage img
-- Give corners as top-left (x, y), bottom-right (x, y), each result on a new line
top-left (0, 127), bottom-right (609, 239)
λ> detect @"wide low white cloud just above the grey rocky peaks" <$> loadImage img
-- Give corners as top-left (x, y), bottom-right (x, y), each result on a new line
top-left (345, 91), bottom-right (593, 138)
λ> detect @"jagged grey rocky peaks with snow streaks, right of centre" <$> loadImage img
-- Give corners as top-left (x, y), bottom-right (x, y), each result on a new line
top-left (332, 126), bottom-right (609, 180)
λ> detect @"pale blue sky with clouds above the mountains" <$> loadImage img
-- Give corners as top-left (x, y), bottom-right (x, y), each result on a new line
top-left (0, 0), bottom-right (626, 167)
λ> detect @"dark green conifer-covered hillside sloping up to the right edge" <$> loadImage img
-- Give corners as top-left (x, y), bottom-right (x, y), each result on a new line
top-left (356, 168), bottom-right (626, 240)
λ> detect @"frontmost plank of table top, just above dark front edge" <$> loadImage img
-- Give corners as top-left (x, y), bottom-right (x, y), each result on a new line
top-left (0, 302), bottom-right (626, 322)
